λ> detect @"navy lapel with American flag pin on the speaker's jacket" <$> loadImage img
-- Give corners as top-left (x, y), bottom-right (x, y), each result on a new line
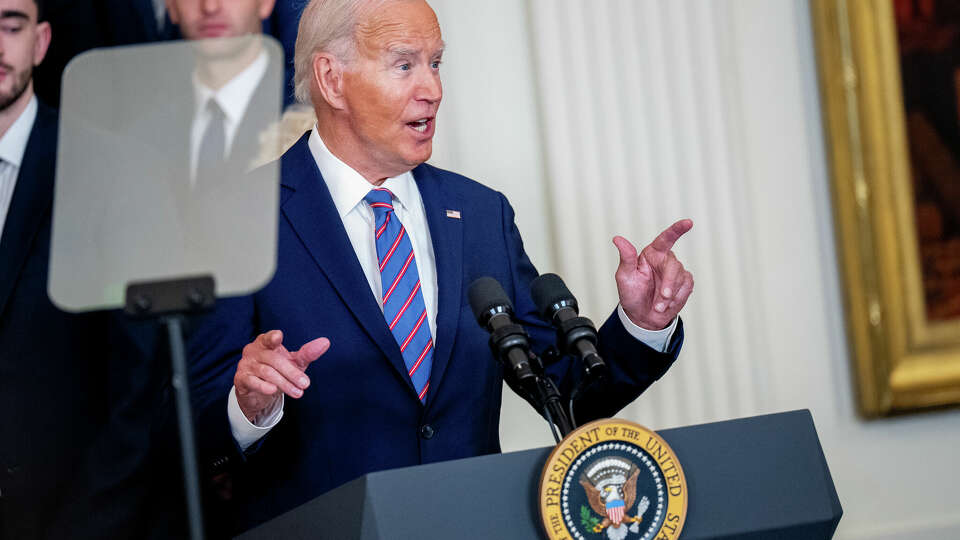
top-left (413, 165), bottom-right (470, 407)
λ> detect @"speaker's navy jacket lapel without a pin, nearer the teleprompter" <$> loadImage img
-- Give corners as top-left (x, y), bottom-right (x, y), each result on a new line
top-left (280, 133), bottom-right (417, 399)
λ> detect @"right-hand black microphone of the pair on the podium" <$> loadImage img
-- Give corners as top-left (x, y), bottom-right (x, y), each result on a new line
top-left (530, 274), bottom-right (607, 377)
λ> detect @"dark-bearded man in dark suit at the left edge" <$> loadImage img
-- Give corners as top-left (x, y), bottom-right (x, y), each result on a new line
top-left (0, 0), bottom-right (73, 538)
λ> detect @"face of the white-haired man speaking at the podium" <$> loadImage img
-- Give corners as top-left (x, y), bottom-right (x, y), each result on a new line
top-left (343, 0), bottom-right (443, 177)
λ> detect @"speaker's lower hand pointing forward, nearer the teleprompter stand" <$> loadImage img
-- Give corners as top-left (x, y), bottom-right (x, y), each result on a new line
top-left (233, 330), bottom-right (330, 424)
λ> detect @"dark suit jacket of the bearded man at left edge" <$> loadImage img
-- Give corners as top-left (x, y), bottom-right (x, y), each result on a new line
top-left (0, 105), bottom-right (77, 538)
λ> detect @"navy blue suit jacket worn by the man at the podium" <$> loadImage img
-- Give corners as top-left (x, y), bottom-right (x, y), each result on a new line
top-left (191, 135), bottom-right (683, 529)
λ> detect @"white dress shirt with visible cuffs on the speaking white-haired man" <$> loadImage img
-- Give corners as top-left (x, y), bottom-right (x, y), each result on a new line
top-left (227, 126), bottom-right (677, 450)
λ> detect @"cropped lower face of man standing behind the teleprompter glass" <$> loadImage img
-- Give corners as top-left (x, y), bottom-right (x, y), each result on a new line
top-left (167, 0), bottom-right (274, 40)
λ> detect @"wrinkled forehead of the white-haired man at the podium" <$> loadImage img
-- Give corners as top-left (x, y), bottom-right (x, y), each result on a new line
top-left (357, 0), bottom-right (443, 56)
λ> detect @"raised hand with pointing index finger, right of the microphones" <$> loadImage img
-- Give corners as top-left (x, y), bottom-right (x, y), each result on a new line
top-left (613, 219), bottom-right (693, 330)
